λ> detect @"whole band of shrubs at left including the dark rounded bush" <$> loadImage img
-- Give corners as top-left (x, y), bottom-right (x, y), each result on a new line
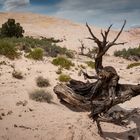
top-left (0, 19), bottom-right (74, 60)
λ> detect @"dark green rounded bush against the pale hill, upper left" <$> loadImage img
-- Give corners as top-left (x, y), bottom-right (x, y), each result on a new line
top-left (1, 19), bottom-right (24, 38)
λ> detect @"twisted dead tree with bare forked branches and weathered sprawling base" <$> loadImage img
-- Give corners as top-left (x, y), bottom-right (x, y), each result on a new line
top-left (54, 21), bottom-right (140, 134)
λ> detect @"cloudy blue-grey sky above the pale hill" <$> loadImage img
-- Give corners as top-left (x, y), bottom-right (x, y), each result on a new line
top-left (0, 0), bottom-right (140, 28)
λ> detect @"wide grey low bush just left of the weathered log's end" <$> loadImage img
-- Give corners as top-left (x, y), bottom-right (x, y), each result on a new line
top-left (29, 89), bottom-right (53, 103)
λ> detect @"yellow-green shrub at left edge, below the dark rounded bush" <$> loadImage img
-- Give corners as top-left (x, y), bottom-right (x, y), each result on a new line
top-left (0, 40), bottom-right (20, 59)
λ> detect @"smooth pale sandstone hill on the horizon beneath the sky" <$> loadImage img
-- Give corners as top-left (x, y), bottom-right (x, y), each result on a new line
top-left (0, 13), bottom-right (140, 53)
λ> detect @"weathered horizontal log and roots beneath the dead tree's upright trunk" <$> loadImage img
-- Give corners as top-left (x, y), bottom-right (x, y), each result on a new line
top-left (54, 83), bottom-right (140, 136)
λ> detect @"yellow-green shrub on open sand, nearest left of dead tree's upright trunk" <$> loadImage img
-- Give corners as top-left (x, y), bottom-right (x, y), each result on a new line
top-left (52, 56), bottom-right (74, 69)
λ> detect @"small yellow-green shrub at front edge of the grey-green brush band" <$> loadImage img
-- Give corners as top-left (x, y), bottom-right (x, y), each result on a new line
top-left (27, 48), bottom-right (43, 60)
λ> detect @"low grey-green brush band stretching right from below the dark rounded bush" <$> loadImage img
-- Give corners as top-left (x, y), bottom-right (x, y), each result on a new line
top-left (1, 36), bottom-right (74, 58)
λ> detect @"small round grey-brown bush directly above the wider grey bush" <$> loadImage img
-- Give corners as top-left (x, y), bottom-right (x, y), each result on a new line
top-left (36, 76), bottom-right (50, 87)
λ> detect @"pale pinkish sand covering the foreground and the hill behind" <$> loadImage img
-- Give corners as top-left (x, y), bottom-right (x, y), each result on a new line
top-left (0, 13), bottom-right (140, 140)
